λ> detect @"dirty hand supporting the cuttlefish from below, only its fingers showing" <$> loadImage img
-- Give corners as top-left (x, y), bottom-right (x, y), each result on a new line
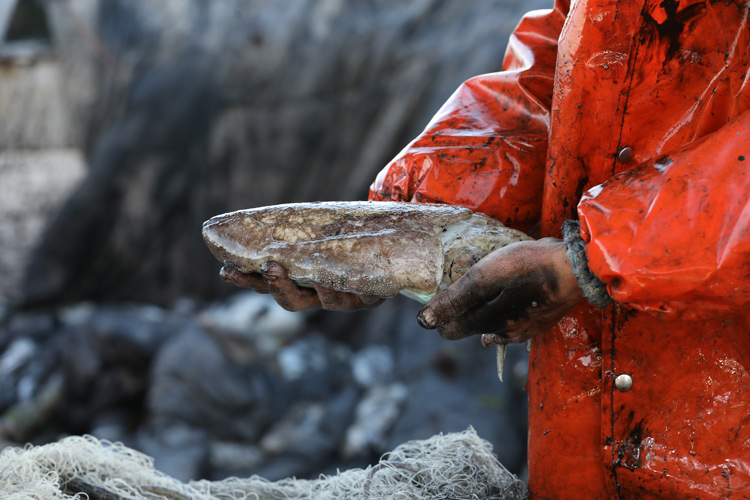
top-left (220, 261), bottom-right (384, 311)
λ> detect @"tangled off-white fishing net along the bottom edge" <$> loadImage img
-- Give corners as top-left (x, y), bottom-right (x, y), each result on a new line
top-left (0, 428), bottom-right (527, 500)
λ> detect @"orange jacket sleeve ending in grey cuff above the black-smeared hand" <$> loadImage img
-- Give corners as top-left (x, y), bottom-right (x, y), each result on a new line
top-left (578, 112), bottom-right (750, 317)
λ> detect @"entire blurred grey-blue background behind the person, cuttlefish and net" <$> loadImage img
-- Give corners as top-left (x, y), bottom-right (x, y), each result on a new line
top-left (0, 0), bottom-right (551, 480)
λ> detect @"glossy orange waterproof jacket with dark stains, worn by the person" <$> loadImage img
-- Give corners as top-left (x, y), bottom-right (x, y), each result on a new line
top-left (371, 0), bottom-right (750, 500)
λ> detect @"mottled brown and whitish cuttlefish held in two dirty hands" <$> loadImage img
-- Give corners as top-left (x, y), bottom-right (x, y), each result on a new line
top-left (203, 201), bottom-right (531, 380)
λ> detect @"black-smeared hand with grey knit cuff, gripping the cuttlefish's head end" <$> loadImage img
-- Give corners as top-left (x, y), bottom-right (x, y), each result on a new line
top-left (417, 238), bottom-right (583, 345)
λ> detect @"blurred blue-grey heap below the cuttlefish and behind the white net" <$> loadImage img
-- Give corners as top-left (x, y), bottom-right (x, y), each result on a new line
top-left (0, 292), bottom-right (527, 480)
